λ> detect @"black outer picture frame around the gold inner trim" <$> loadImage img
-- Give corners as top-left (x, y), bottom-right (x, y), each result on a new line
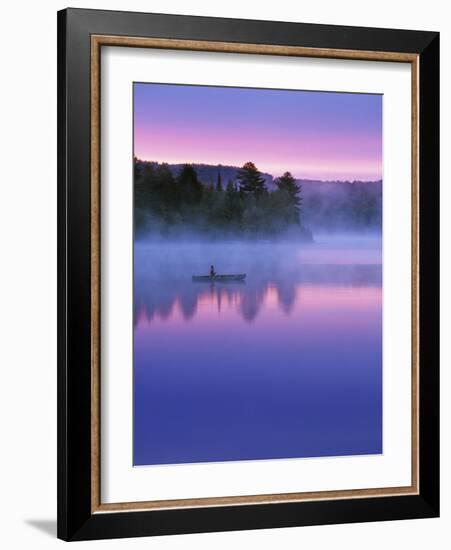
top-left (58, 9), bottom-right (439, 540)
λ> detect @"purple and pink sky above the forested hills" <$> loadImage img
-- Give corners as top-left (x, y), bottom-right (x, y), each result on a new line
top-left (134, 83), bottom-right (382, 181)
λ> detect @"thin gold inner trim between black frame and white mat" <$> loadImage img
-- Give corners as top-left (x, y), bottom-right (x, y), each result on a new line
top-left (91, 35), bottom-right (420, 514)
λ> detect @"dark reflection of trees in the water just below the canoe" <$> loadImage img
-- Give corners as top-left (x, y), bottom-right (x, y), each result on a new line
top-left (134, 264), bottom-right (382, 325)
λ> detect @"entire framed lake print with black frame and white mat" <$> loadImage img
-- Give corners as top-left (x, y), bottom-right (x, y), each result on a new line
top-left (58, 9), bottom-right (439, 540)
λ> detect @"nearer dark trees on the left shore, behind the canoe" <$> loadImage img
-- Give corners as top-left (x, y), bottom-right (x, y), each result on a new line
top-left (134, 158), bottom-right (308, 235)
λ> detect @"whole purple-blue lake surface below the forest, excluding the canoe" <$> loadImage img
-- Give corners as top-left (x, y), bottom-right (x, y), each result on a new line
top-left (134, 237), bottom-right (382, 465)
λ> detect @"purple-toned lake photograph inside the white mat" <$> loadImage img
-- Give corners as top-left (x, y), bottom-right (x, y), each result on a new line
top-left (130, 82), bottom-right (384, 466)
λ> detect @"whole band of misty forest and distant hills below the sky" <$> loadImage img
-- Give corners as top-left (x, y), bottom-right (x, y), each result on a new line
top-left (134, 158), bottom-right (382, 241)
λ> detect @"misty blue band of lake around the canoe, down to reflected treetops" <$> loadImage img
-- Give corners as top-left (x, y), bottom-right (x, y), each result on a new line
top-left (134, 234), bottom-right (381, 322)
